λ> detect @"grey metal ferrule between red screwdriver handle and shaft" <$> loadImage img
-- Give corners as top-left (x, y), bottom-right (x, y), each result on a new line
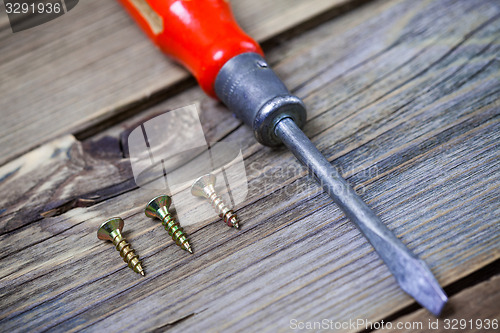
top-left (215, 52), bottom-right (306, 146)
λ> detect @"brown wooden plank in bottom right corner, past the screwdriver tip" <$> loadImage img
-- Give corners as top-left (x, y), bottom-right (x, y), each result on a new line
top-left (375, 275), bottom-right (500, 333)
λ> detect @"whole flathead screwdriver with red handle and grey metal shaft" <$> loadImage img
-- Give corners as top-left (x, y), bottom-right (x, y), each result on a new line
top-left (118, 0), bottom-right (448, 316)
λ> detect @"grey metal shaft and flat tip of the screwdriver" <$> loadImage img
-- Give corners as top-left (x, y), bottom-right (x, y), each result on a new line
top-left (275, 118), bottom-right (448, 316)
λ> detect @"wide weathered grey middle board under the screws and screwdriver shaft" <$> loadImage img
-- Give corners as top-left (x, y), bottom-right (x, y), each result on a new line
top-left (0, 1), bottom-right (500, 331)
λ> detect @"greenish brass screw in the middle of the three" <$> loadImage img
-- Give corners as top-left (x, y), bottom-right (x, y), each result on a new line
top-left (144, 195), bottom-right (193, 253)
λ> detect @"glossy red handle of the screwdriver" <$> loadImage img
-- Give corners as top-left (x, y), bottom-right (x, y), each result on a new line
top-left (118, 0), bottom-right (263, 97)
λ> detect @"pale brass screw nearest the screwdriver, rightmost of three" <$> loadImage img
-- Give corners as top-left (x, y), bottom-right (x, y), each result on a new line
top-left (191, 173), bottom-right (240, 229)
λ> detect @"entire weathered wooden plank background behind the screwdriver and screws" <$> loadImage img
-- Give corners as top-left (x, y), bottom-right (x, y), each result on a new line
top-left (0, 0), bottom-right (500, 332)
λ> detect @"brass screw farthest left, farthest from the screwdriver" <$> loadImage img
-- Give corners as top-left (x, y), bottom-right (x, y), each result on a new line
top-left (97, 217), bottom-right (144, 276)
